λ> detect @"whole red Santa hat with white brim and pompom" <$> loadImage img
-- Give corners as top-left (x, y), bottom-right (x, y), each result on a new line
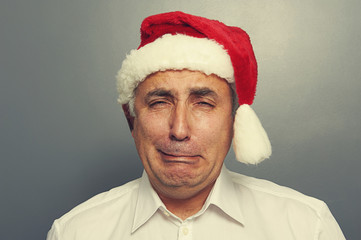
top-left (117, 12), bottom-right (271, 164)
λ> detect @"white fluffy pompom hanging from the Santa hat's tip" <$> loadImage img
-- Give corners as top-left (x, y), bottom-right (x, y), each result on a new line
top-left (233, 104), bottom-right (272, 164)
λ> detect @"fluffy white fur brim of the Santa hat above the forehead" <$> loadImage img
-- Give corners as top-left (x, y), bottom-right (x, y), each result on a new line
top-left (117, 34), bottom-right (234, 104)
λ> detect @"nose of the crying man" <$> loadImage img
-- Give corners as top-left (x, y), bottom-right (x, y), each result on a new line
top-left (170, 105), bottom-right (190, 141)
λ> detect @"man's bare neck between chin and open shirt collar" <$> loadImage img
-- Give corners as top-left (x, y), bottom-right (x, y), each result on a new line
top-left (158, 182), bottom-right (214, 220)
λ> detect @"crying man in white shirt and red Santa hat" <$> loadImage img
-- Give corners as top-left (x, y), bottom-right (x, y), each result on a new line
top-left (48, 12), bottom-right (344, 240)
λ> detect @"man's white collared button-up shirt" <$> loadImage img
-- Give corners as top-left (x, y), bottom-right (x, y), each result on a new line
top-left (47, 167), bottom-right (345, 240)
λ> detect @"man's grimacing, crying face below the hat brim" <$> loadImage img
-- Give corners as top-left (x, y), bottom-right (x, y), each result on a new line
top-left (132, 70), bottom-right (233, 199)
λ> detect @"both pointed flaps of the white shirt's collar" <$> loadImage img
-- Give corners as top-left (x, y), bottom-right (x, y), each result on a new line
top-left (132, 166), bottom-right (244, 233)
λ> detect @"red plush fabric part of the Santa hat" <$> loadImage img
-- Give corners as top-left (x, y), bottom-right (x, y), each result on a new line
top-left (138, 12), bottom-right (257, 105)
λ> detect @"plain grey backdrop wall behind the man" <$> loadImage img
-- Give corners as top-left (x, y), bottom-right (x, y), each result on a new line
top-left (0, 0), bottom-right (361, 240)
